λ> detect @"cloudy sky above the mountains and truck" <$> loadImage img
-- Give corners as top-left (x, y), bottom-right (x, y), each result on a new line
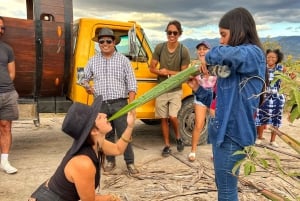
top-left (0, 0), bottom-right (300, 40)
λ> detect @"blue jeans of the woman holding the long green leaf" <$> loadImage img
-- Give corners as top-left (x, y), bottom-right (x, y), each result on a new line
top-left (212, 136), bottom-right (245, 201)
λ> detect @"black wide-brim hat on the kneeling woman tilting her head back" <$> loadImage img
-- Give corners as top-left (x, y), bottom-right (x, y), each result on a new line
top-left (62, 96), bottom-right (102, 155)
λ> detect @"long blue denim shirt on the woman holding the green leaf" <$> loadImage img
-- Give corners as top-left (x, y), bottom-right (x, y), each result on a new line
top-left (205, 44), bottom-right (266, 147)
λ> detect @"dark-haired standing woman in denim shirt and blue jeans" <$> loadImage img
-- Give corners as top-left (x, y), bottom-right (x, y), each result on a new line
top-left (202, 8), bottom-right (266, 201)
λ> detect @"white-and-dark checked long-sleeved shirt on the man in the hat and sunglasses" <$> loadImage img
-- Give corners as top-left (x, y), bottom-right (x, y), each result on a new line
top-left (83, 52), bottom-right (137, 100)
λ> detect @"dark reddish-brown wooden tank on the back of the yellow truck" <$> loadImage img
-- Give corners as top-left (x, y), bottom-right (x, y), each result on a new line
top-left (3, 0), bottom-right (73, 119)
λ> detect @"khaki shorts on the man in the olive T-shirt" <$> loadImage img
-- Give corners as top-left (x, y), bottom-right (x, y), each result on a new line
top-left (155, 89), bottom-right (182, 118)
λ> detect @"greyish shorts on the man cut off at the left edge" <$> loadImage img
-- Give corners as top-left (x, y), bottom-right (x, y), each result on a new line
top-left (0, 91), bottom-right (19, 121)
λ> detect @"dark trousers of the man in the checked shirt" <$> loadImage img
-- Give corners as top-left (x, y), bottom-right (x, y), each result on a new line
top-left (101, 99), bottom-right (134, 164)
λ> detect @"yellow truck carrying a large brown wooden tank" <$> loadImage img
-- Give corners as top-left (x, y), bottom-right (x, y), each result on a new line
top-left (3, 0), bottom-right (207, 145)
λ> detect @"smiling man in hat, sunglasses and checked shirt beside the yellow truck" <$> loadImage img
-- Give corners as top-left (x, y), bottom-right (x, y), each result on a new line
top-left (81, 28), bottom-right (139, 174)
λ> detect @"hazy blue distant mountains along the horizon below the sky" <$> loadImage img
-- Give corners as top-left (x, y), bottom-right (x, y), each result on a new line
top-left (152, 36), bottom-right (300, 59)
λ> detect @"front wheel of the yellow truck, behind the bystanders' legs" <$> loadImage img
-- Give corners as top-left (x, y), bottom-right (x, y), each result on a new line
top-left (178, 97), bottom-right (209, 145)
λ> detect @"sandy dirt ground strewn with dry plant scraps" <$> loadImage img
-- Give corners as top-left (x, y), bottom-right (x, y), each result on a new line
top-left (0, 114), bottom-right (300, 201)
